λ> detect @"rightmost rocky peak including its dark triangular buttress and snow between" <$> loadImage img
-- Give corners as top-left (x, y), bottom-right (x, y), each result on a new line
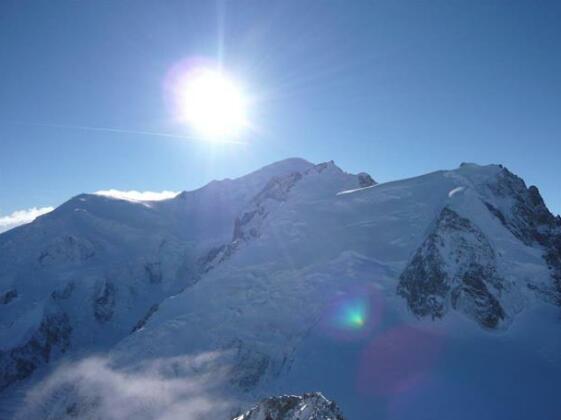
top-left (398, 164), bottom-right (560, 328)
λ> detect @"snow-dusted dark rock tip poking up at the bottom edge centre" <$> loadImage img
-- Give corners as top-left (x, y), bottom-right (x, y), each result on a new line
top-left (234, 392), bottom-right (344, 420)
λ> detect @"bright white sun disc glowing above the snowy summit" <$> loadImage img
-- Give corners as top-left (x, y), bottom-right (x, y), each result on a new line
top-left (175, 68), bottom-right (248, 141)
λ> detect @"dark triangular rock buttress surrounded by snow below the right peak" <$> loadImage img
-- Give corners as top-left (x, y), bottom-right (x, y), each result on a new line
top-left (397, 207), bottom-right (507, 328)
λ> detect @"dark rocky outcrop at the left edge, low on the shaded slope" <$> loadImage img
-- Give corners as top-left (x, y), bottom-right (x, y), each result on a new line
top-left (0, 310), bottom-right (72, 391)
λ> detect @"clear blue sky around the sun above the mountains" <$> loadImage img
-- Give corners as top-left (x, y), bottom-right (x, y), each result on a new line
top-left (0, 0), bottom-right (561, 220)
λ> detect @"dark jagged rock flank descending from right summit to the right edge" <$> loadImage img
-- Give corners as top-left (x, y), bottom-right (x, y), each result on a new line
top-left (485, 169), bottom-right (561, 305)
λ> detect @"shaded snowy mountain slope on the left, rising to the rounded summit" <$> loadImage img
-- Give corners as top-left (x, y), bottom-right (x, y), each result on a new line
top-left (0, 159), bottom-right (328, 389)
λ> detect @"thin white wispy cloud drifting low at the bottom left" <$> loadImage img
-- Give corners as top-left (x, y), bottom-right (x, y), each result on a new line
top-left (18, 353), bottom-right (233, 420)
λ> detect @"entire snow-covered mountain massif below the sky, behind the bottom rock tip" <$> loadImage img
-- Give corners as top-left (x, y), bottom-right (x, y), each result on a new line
top-left (0, 159), bottom-right (561, 419)
